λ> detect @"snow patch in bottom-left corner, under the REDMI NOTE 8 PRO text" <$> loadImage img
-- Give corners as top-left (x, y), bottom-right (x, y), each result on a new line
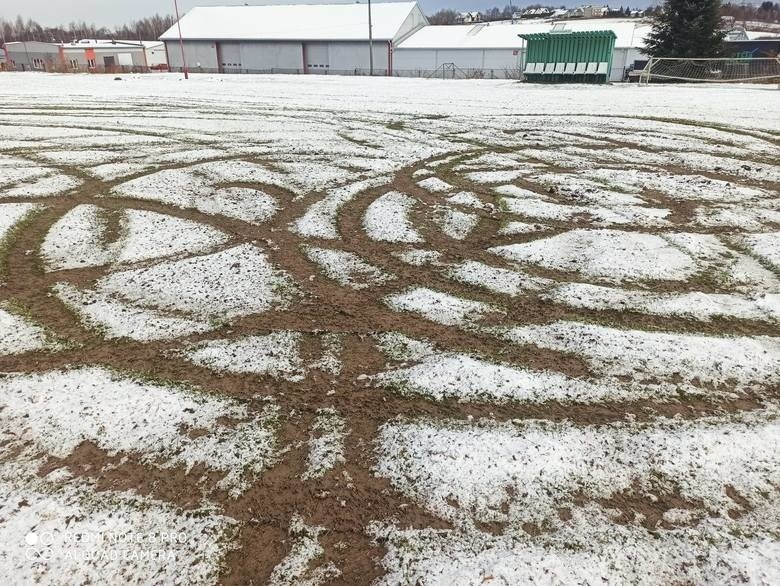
top-left (0, 452), bottom-right (235, 584)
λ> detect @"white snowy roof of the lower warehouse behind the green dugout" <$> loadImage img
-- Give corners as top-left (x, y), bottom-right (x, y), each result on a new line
top-left (398, 18), bottom-right (650, 49)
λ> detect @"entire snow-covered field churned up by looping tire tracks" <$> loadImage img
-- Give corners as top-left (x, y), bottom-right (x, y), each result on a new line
top-left (0, 74), bottom-right (780, 586)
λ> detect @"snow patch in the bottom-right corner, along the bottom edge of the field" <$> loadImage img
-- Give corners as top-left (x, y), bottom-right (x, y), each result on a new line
top-left (369, 505), bottom-right (780, 586)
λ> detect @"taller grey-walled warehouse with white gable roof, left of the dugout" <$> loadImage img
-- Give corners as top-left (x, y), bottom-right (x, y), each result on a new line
top-left (160, 2), bottom-right (428, 75)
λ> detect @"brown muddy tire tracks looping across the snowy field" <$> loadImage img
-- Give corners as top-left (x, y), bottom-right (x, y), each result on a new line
top-left (0, 110), bottom-right (777, 584)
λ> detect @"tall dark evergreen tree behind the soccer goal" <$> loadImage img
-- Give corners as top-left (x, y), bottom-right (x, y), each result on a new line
top-left (644, 0), bottom-right (725, 58)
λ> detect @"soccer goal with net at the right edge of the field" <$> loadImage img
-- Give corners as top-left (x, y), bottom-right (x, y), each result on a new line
top-left (639, 57), bottom-right (780, 83)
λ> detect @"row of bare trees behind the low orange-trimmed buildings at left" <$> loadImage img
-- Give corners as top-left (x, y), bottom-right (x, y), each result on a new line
top-left (0, 14), bottom-right (176, 43)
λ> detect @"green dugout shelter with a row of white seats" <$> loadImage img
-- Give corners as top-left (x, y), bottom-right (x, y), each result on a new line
top-left (517, 30), bottom-right (617, 83)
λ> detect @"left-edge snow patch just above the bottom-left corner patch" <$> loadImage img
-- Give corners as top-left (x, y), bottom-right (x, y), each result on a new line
top-left (0, 367), bottom-right (278, 495)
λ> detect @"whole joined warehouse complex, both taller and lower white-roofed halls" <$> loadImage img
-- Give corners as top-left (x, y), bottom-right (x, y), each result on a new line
top-left (160, 2), bottom-right (650, 81)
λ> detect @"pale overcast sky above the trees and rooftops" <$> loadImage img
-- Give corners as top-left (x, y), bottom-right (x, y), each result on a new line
top-left (0, 0), bottom-right (661, 27)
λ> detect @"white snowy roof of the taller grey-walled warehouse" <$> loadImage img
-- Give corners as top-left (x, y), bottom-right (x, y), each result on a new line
top-left (160, 2), bottom-right (424, 41)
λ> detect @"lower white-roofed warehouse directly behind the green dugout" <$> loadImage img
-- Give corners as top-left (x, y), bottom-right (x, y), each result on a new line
top-left (393, 18), bottom-right (650, 81)
